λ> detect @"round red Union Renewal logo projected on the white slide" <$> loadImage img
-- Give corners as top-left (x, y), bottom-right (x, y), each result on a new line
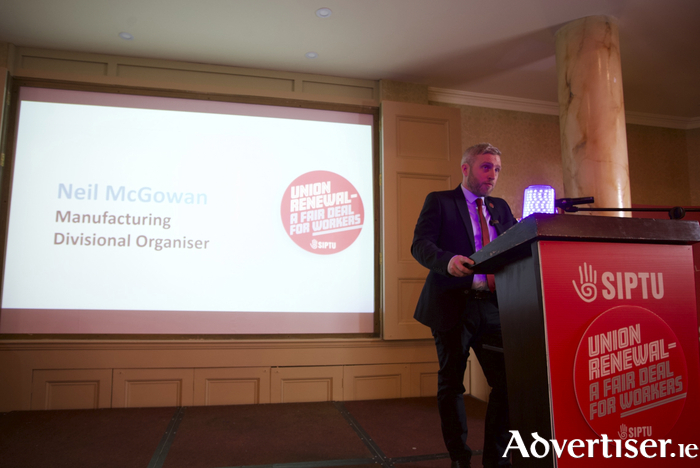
top-left (282, 171), bottom-right (365, 255)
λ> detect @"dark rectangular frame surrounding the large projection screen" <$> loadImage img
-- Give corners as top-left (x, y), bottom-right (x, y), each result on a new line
top-left (0, 78), bottom-right (382, 340)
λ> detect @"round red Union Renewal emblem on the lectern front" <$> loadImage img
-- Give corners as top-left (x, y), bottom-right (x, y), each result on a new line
top-left (574, 305), bottom-right (688, 440)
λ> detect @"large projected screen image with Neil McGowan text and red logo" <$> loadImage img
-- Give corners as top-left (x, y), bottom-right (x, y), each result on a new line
top-left (0, 88), bottom-right (375, 334)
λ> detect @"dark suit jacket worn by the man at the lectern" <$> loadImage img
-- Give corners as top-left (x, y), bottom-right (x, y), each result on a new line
top-left (411, 186), bottom-right (517, 331)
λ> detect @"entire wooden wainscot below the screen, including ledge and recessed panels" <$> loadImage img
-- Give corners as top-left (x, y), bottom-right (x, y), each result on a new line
top-left (0, 338), bottom-right (437, 412)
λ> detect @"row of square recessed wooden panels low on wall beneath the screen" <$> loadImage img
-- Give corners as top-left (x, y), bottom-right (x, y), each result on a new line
top-left (20, 359), bottom-right (464, 410)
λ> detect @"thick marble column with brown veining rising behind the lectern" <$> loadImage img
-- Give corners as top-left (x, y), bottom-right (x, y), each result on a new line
top-left (556, 16), bottom-right (631, 216)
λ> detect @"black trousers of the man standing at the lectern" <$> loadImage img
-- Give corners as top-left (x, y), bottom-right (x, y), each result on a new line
top-left (433, 296), bottom-right (511, 467)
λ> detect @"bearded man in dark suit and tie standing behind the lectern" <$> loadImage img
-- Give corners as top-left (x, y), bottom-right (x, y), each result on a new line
top-left (411, 143), bottom-right (516, 468)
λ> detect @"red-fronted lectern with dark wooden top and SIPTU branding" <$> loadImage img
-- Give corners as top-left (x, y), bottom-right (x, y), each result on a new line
top-left (472, 214), bottom-right (700, 468)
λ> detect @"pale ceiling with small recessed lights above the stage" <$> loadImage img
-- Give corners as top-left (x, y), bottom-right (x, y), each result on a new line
top-left (0, 0), bottom-right (700, 119)
